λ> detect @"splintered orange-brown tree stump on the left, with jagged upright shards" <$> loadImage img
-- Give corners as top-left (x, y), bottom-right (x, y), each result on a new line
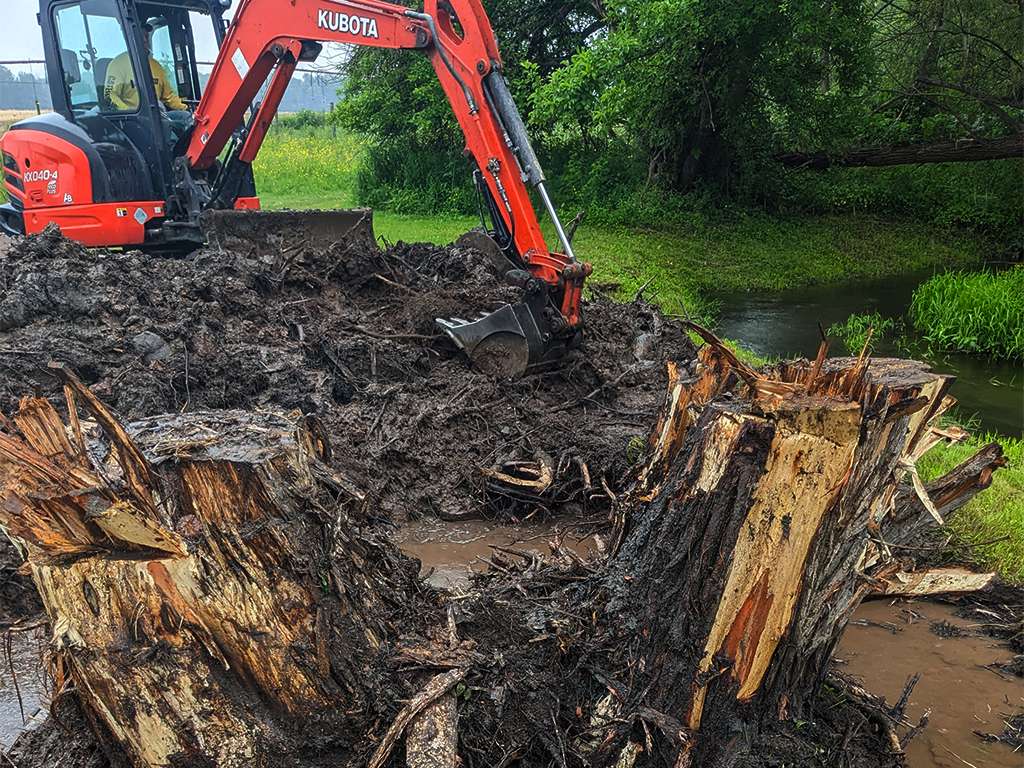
top-left (0, 374), bottom-right (416, 766)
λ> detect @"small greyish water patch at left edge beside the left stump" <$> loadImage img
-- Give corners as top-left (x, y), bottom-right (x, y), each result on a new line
top-left (0, 629), bottom-right (48, 750)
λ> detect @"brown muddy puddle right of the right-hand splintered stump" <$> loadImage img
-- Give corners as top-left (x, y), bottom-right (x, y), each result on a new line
top-left (836, 601), bottom-right (1024, 768)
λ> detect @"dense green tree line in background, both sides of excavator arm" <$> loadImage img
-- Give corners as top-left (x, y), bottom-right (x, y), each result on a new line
top-left (337, 0), bottom-right (1024, 225)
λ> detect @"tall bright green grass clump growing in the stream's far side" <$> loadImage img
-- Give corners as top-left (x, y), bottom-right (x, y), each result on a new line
top-left (910, 265), bottom-right (1024, 359)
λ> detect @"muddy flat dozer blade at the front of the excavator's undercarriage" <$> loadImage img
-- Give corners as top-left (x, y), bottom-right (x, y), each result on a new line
top-left (200, 208), bottom-right (374, 248)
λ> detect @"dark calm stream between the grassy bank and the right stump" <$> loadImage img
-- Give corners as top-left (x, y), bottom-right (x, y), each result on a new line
top-left (715, 272), bottom-right (1024, 437)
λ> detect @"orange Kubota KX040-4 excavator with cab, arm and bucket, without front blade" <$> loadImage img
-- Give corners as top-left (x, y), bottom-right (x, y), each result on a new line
top-left (0, 0), bottom-right (590, 376)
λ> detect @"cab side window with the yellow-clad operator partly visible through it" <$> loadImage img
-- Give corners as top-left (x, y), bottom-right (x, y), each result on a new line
top-left (54, 0), bottom-right (138, 114)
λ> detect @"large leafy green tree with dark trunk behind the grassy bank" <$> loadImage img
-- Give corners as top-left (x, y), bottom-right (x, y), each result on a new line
top-left (532, 0), bottom-right (870, 189)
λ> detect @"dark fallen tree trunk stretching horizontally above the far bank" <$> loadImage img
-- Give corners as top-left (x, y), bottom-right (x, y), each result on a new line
top-left (775, 133), bottom-right (1024, 171)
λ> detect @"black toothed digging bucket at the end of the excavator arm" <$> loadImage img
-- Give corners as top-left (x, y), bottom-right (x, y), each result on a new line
top-left (436, 303), bottom-right (545, 379)
